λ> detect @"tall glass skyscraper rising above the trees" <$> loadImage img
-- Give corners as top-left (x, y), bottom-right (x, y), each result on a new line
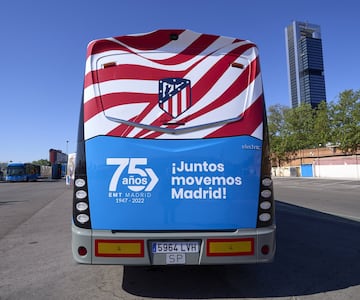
top-left (285, 21), bottom-right (326, 108)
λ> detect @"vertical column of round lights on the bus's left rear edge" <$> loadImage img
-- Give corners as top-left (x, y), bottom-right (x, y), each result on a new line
top-left (73, 178), bottom-right (91, 228)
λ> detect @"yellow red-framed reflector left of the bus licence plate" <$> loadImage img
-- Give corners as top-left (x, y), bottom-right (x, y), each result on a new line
top-left (95, 240), bottom-right (144, 257)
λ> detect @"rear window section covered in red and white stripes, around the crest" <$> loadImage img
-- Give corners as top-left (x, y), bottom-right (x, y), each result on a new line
top-left (96, 52), bottom-right (252, 137)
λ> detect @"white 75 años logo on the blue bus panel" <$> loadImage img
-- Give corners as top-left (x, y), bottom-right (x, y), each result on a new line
top-left (106, 158), bottom-right (159, 192)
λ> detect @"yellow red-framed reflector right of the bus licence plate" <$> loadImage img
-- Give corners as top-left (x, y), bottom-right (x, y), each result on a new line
top-left (206, 238), bottom-right (255, 256)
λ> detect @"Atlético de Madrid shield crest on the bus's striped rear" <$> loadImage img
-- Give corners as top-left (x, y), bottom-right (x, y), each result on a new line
top-left (159, 78), bottom-right (191, 118)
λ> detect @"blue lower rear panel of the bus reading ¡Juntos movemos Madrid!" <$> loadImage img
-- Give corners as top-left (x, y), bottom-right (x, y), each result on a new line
top-left (85, 136), bottom-right (262, 230)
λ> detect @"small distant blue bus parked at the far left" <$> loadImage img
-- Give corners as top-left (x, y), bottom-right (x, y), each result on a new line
top-left (6, 163), bottom-right (40, 181)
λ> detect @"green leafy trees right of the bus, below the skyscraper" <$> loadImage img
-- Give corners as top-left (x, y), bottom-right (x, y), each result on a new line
top-left (268, 90), bottom-right (360, 166)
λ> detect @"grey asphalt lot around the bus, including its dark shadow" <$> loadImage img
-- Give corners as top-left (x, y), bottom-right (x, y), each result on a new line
top-left (0, 178), bottom-right (360, 300)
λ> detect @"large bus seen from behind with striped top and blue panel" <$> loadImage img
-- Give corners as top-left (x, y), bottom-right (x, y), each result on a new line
top-left (72, 29), bottom-right (276, 266)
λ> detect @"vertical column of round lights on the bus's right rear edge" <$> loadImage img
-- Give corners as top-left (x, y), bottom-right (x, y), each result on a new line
top-left (257, 177), bottom-right (274, 227)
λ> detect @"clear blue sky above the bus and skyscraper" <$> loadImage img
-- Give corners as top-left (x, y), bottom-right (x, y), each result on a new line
top-left (0, 0), bottom-right (360, 162)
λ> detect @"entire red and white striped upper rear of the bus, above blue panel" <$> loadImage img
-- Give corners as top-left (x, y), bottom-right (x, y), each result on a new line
top-left (84, 30), bottom-right (263, 139)
